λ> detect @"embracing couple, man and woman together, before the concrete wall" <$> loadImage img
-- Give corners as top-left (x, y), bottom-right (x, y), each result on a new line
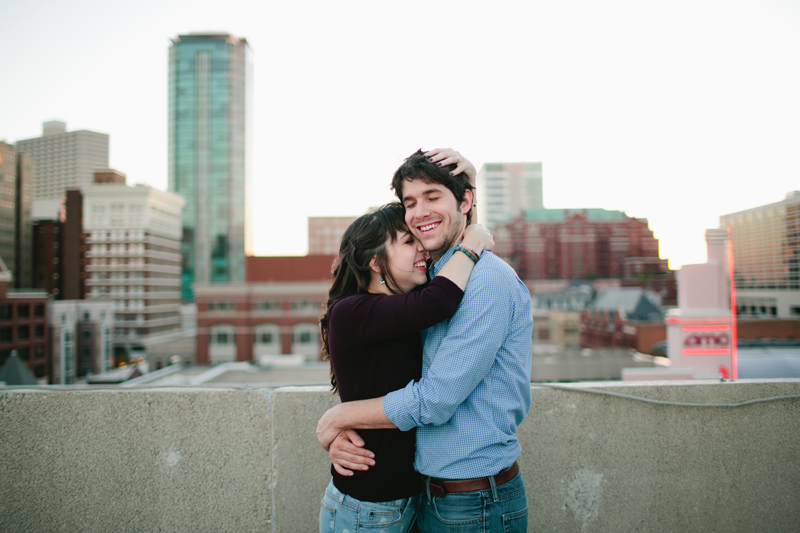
top-left (317, 149), bottom-right (533, 533)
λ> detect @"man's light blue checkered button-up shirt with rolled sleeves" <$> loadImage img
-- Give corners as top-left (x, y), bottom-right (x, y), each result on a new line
top-left (383, 248), bottom-right (533, 479)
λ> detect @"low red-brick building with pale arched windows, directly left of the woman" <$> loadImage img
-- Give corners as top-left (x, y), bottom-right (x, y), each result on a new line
top-left (194, 255), bottom-right (335, 365)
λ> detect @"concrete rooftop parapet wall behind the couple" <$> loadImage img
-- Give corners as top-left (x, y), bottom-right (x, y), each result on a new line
top-left (0, 379), bottom-right (800, 533)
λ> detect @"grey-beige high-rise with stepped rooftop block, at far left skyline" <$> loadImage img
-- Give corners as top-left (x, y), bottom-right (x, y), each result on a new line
top-left (17, 121), bottom-right (108, 200)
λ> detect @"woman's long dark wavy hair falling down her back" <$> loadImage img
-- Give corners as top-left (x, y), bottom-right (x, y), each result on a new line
top-left (319, 202), bottom-right (408, 392)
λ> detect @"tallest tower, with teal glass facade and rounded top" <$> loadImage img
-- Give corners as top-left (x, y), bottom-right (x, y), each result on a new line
top-left (168, 33), bottom-right (251, 300)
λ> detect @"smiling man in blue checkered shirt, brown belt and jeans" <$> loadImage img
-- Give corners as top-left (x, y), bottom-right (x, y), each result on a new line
top-left (317, 151), bottom-right (533, 531)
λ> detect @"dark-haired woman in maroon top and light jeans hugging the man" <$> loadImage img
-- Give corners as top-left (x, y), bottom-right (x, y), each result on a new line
top-left (320, 150), bottom-right (494, 533)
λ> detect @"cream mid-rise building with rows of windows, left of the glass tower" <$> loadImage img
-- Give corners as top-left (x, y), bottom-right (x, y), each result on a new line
top-left (82, 179), bottom-right (184, 358)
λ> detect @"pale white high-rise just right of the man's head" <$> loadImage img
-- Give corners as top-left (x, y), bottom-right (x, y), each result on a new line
top-left (475, 163), bottom-right (544, 230)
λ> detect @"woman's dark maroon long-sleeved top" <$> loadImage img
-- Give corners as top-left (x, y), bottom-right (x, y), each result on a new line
top-left (328, 276), bottom-right (464, 502)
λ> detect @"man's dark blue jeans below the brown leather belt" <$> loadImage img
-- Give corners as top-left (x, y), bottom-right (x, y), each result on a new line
top-left (417, 473), bottom-right (528, 533)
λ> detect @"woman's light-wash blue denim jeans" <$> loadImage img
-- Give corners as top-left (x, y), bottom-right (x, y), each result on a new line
top-left (319, 481), bottom-right (420, 533)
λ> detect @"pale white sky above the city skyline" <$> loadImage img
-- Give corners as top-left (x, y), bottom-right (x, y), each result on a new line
top-left (0, 0), bottom-right (800, 268)
